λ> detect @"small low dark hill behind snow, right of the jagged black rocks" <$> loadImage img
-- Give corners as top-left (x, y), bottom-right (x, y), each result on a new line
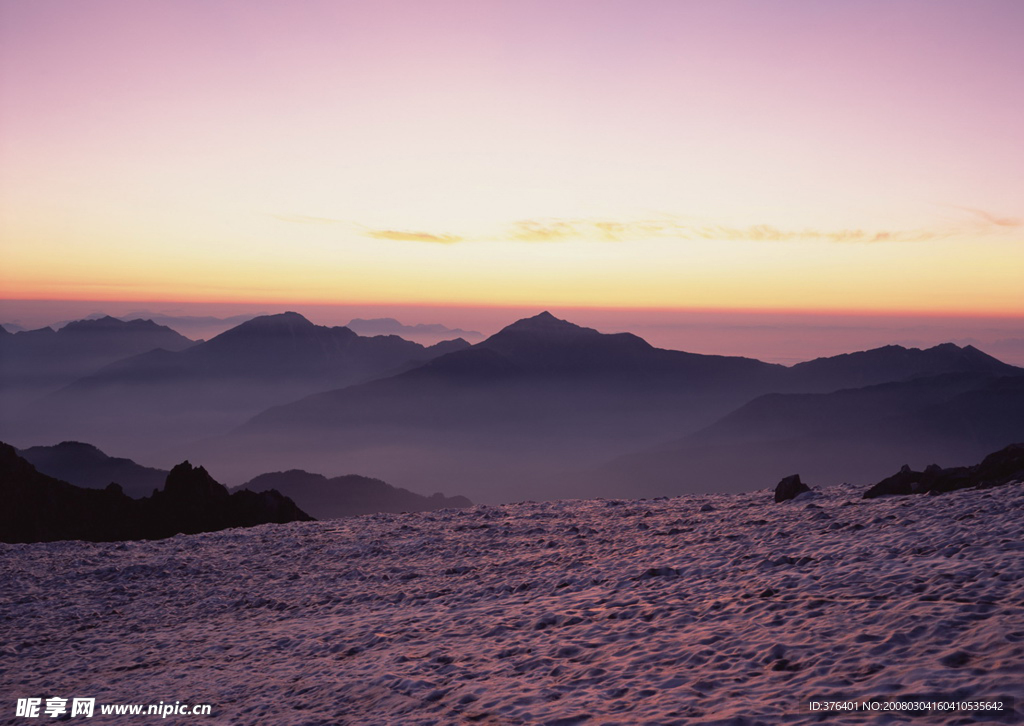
top-left (241, 469), bottom-right (472, 519)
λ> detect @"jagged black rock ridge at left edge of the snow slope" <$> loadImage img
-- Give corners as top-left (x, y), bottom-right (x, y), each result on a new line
top-left (0, 443), bottom-right (311, 543)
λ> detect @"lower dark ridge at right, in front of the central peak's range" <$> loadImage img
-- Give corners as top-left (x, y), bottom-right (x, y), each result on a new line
top-left (593, 368), bottom-right (1024, 497)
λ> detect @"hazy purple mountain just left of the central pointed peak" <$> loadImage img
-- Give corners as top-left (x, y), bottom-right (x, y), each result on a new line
top-left (17, 312), bottom-right (468, 452)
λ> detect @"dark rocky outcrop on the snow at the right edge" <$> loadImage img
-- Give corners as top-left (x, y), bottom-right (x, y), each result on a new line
top-left (864, 443), bottom-right (1024, 499)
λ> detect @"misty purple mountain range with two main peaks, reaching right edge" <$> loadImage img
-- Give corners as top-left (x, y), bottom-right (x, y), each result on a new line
top-left (0, 312), bottom-right (1024, 502)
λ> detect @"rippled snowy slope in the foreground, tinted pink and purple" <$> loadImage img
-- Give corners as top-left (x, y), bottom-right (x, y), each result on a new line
top-left (0, 484), bottom-right (1024, 724)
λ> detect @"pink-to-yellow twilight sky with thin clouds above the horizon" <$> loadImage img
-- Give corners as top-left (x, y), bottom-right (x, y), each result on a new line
top-left (0, 0), bottom-right (1024, 322)
